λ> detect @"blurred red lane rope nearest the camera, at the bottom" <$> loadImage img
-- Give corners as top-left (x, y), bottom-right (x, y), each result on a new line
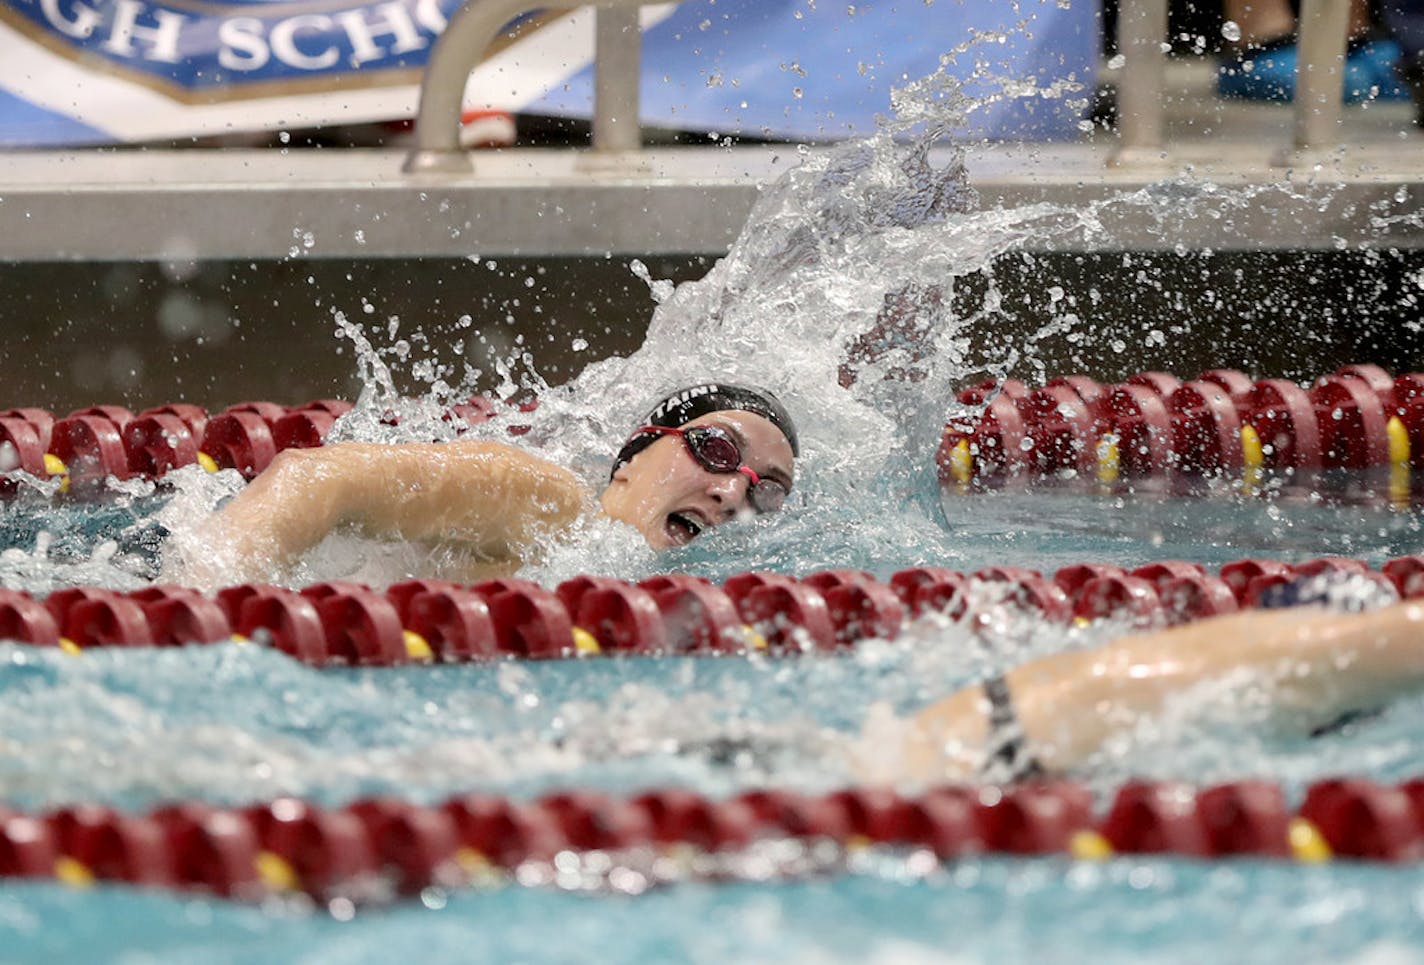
top-left (0, 779), bottom-right (1424, 901)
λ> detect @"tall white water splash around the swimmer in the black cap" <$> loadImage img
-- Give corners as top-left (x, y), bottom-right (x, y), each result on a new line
top-left (27, 43), bottom-right (1411, 584)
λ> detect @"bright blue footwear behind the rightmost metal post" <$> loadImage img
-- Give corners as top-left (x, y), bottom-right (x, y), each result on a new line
top-left (1216, 37), bottom-right (1410, 104)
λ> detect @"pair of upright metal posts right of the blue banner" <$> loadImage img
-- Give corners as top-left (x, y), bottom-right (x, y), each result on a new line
top-left (1112, 0), bottom-right (1350, 165)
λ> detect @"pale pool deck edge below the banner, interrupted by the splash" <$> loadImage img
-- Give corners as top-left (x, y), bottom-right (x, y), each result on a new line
top-left (0, 61), bottom-right (1424, 262)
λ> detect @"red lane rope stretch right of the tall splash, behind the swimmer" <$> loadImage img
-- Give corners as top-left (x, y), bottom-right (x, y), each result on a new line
top-left (937, 366), bottom-right (1424, 483)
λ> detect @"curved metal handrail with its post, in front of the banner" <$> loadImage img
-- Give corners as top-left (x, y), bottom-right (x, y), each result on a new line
top-left (404, 0), bottom-right (652, 174)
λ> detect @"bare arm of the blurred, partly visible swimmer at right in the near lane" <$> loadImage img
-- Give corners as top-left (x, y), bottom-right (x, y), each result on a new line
top-left (871, 602), bottom-right (1424, 780)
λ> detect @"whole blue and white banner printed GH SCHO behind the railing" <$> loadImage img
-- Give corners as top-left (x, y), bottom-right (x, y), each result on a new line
top-left (0, 0), bottom-right (1099, 145)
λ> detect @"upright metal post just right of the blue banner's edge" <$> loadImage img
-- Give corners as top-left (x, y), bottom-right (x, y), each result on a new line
top-left (1112, 0), bottom-right (1168, 164)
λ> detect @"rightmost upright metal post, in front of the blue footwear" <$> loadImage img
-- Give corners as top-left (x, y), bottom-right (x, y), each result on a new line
top-left (1294, 0), bottom-right (1350, 152)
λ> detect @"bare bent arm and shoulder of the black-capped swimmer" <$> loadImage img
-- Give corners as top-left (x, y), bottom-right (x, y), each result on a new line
top-left (182, 440), bottom-right (588, 582)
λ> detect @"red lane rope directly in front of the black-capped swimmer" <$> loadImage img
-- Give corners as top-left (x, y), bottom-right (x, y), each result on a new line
top-left (0, 557), bottom-right (1424, 666)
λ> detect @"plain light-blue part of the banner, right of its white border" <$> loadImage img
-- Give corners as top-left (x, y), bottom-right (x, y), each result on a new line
top-left (527, 0), bottom-right (1101, 141)
